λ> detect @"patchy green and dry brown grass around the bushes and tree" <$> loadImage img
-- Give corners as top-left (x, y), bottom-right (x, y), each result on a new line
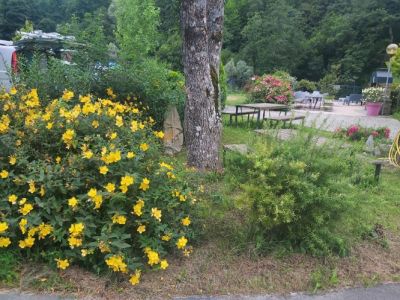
top-left (0, 120), bottom-right (400, 299)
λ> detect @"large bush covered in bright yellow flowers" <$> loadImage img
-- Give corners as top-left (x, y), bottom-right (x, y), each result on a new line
top-left (0, 89), bottom-right (193, 284)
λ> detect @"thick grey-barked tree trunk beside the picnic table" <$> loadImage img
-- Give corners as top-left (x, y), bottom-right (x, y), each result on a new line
top-left (182, 0), bottom-right (224, 170)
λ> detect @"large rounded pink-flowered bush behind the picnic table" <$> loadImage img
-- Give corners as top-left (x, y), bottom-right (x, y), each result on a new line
top-left (248, 75), bottom-right (293, 104)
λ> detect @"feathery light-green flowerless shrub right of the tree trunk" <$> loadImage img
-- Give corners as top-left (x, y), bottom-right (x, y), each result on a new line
top-left (227, 134), bottom-right (372, 255)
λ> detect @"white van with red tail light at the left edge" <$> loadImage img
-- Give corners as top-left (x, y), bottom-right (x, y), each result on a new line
top-left (0, 40), bottom-right (18, 91)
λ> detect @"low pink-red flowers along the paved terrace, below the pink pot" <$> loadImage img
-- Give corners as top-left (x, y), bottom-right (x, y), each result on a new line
top-left (335, 125), bottom-right (390, 141)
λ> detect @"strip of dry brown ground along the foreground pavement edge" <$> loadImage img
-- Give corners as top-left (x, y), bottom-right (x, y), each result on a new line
top-left (13, 234), bottom-right (400, 300)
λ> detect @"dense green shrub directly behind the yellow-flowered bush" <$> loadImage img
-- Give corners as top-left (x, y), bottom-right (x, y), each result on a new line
top-left (17, 52), bottom-right (185, 126)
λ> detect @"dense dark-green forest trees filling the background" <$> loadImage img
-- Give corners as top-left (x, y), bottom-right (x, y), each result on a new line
top-left (0, 0), bottom-right (400, 85)
